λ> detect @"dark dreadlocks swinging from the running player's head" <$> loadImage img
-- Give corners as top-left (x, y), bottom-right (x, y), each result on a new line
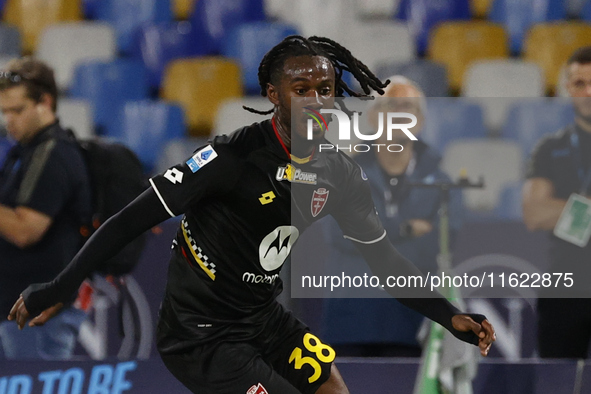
top-left (243, 35), bottom-right (390, 115)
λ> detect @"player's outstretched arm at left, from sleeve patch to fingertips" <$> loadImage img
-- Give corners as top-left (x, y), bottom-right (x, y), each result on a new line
top-left (8, 145), bottom-right (240, 327)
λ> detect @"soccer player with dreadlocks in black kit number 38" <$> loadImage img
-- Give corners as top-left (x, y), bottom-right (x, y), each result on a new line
top-left (10, 36), bottom-right (495, 394)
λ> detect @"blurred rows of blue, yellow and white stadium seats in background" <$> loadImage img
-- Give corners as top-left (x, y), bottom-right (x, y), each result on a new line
top-left (0, 0), bottom-right (591, 219)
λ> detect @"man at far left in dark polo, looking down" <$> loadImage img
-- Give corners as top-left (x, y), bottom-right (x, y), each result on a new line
top-left (0, 57), bottom-right (91, 359)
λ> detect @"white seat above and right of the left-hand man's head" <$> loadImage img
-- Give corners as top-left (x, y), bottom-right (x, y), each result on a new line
top-left (35, 22), bottom-right (116, 90)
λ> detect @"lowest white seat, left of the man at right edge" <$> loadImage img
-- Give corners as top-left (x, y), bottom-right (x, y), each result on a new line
top-left (442, 139), bottom-right (523, 213)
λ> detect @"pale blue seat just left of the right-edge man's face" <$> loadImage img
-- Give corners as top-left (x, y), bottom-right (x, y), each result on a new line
top-left (502, 98), bottom-right (574, 157)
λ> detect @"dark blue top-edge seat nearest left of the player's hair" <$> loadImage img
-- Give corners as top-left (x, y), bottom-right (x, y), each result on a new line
top-left (190, 0), bottom-right (265, 54)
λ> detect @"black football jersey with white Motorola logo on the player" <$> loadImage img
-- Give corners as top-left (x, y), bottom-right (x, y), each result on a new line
top-left (150, 120), bottom-right (385, 339)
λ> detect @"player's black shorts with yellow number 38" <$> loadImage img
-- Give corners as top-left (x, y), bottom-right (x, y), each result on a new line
top-left (161, 308), bottom-right (335, 394)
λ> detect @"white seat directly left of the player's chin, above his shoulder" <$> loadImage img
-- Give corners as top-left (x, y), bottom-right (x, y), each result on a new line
top-left (211, 97), bottom-right (273, 138)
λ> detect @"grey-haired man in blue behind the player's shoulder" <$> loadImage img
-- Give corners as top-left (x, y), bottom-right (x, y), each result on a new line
top-left (323, 76), bottom-right (462, 357)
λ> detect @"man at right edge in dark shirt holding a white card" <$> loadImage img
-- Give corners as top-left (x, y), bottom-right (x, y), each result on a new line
top-left (523, 46), bottom-right (591, 358)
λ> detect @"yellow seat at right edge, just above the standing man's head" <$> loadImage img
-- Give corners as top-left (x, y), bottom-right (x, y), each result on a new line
top-left (523, 22), bottom-right (591, 92)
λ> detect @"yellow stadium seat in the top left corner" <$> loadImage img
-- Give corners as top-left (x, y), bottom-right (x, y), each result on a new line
top-left (4, 0), bottom-right (82, 54)
